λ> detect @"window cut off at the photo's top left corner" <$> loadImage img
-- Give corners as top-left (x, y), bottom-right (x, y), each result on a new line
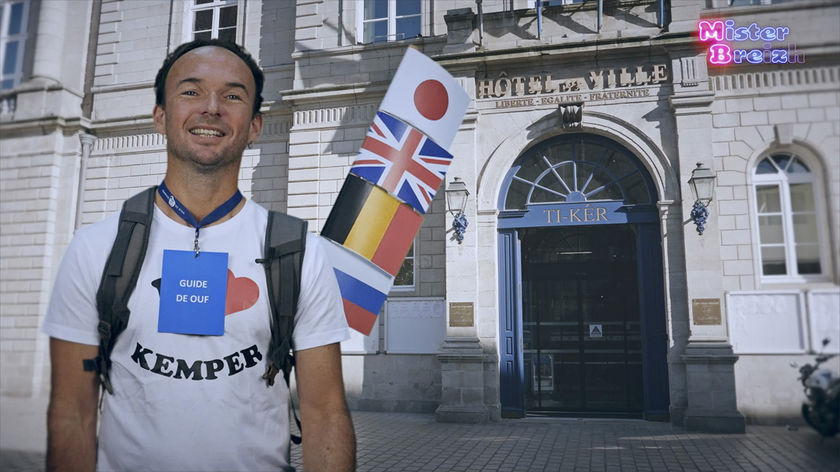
top-left (0, 0), bottom-right (29, 90)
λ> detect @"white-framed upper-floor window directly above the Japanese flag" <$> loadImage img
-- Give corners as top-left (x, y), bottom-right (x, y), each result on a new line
top-left (358, 0), bottom-right (422, 44)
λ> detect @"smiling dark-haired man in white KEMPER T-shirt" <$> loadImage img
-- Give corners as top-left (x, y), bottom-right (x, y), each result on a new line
top-left (43, 41), bottom-right (355, 471)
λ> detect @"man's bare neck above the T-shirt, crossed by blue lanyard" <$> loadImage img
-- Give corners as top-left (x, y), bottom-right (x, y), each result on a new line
top-left (156, 167), bottom-right (245, 224)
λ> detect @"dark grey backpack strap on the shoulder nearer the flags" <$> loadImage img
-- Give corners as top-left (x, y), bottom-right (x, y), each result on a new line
top-left (257, 211), bottom-right (308, 386)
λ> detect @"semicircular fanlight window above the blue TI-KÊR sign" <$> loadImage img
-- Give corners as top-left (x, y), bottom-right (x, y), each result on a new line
top-left (504, 135), bottom-right (656, 210)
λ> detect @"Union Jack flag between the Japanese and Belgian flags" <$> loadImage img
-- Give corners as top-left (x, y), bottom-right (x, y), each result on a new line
top-left (350, 111), bottom-right (452, 214)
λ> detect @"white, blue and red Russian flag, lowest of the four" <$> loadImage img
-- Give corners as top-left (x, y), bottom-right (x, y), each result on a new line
top-left (326, 239), bottom-right (394, 335)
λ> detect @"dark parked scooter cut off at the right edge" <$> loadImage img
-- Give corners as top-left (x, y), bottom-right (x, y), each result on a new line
top-left (799, 338), bottom-right (840, 437)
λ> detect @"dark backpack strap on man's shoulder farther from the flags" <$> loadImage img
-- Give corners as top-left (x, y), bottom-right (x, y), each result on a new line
top-left (84, 186), bottom-right (157, 394)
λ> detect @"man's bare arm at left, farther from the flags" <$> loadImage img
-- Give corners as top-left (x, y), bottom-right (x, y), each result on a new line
top-left (47, 338), bottom-right (99, 472)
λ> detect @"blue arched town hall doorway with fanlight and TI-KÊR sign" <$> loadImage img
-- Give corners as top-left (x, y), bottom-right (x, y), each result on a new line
top-left (498, 133), bottom-right (668, 419)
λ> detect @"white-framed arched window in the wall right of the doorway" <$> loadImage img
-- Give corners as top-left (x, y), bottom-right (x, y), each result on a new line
top-left (753, 152), bottom-right (826, 280)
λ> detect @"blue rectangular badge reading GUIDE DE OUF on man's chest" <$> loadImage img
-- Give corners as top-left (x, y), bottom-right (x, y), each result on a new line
top-left (158, 249), bottom-right (228, 336)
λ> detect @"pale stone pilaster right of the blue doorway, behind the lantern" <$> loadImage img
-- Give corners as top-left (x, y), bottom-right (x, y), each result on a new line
top-left (671, 56), bottom-right (744, 433)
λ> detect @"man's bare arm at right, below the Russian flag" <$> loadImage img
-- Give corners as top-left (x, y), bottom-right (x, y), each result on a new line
top-left (295, 344), bottom-right (356, 472)
